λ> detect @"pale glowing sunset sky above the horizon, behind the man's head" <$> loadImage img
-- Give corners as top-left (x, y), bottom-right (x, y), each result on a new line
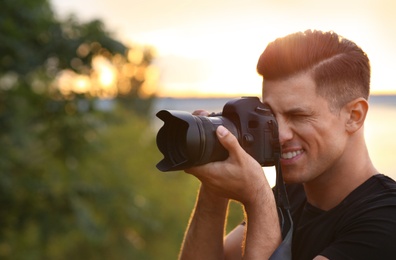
top-left (51, 0), bottom-right (396, 97)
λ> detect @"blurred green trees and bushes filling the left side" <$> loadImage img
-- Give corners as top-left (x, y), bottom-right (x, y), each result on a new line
top-left (0, 0), bottom-right (242, 259)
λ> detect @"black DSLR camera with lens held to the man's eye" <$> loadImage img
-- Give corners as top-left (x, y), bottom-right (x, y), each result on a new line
top-left (156, 97), bottom-right (280, 172)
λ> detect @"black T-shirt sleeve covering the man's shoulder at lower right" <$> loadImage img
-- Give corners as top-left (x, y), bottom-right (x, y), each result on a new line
top-left (322, 175), bottom-right (396, 259)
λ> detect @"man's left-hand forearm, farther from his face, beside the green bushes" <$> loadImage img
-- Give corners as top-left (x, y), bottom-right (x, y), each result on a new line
top-left (180, 187), bottom-right (228, 260)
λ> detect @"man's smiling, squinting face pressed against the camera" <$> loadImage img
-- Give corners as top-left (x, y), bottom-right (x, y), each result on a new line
top-left (263, 73), bottom-right (347, 183)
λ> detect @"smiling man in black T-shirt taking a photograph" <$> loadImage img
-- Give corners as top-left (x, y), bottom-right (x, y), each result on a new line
top-left (180, 31), bottom-right (396, 259)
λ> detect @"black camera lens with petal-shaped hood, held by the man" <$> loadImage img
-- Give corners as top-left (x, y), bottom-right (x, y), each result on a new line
top-left (157, 110), bottom-right (238, 171)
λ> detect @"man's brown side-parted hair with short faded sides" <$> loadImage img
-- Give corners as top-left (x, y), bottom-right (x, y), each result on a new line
top-left (257, 30), bottom-right (370, 110)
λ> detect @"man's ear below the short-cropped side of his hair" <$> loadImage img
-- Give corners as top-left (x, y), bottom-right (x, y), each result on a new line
top-left (344, 98), bottom-right (369, 134)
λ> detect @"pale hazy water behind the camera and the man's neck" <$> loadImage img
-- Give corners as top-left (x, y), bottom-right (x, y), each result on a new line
top-left (153, 95), bottom-right (396, 180)
